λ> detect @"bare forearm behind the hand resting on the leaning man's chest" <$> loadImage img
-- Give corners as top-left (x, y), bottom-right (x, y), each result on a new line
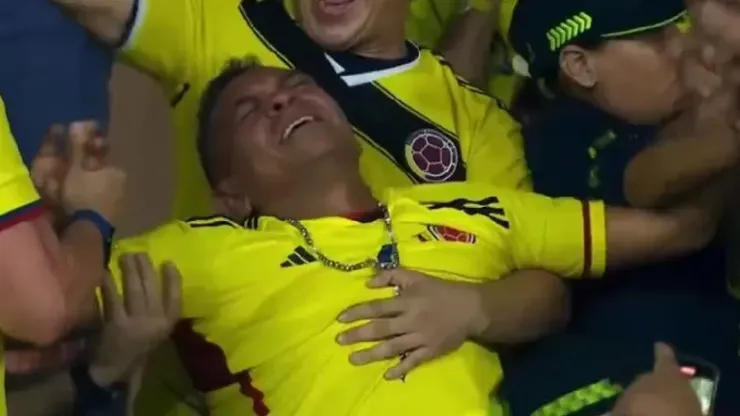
top-left (473, 269), bottom-right (570, 345)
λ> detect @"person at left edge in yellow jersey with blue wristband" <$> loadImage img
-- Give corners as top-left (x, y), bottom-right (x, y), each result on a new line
top-left (0, 99), bottom-right (124, 415)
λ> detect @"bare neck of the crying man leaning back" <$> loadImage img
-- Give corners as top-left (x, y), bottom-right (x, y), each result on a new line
top-left (259, 158), bottom-right (378, 220)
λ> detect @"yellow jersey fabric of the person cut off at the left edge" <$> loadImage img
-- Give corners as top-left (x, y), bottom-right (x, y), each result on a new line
top-left (0, 97), bottom-right (39, 416)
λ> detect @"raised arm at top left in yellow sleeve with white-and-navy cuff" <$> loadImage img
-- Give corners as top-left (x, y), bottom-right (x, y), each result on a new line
top-left (53, 0), bottom-right (199, 93)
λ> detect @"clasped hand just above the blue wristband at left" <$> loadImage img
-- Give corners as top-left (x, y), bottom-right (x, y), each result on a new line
top-left (61, 122), bottom-right (126, 223)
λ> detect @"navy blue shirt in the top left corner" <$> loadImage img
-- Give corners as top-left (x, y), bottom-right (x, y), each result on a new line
top-left (0, 0), bottom-right (113, 162)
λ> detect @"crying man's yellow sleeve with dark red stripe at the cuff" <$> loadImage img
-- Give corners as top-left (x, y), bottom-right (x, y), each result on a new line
top-left (500, 193), bottom-right (606, 278)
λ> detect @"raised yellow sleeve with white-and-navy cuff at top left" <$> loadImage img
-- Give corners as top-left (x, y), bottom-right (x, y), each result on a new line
top-left (120, 0), bottom-right (204, 94)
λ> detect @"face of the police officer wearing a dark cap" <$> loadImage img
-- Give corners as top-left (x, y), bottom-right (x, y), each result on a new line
top-left (592, 26), bottom-right (687, 124)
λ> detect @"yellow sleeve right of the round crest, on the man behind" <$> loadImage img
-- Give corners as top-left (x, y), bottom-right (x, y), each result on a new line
top-left (466, 94), bottom-right (532, 191)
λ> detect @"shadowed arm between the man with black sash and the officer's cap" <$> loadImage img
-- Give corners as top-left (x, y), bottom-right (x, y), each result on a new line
top-left (437, 0), bottom-right (499, 88)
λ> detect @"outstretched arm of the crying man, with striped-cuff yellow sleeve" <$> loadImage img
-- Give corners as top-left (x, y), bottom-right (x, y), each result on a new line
top-left (497, 187), bottom-right (716, 278)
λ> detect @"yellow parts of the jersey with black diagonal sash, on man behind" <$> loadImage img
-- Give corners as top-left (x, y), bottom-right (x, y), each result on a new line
top-left (121, 0), bottom-right (529, 218)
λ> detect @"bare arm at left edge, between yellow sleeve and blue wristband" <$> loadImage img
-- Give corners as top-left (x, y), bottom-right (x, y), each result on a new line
top-left (0, 216), bottom-right (103, 345)
